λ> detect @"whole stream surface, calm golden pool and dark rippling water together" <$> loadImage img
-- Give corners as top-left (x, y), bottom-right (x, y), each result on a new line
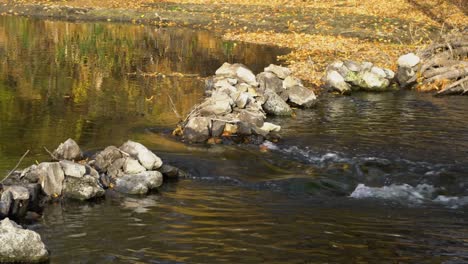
top-left (0, 17), bottom-right (468, 263)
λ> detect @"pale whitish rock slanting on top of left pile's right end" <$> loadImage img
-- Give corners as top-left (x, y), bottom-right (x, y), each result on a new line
top-left (120, 140), bottom-right (162, 170)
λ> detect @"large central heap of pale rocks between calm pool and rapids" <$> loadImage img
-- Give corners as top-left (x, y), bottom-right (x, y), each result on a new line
top-left (178, 63), bottom-right (316, 143)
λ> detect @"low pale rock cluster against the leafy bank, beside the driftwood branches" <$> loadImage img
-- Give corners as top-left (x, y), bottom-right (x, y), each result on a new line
top-left (323, 61), bottom-right (395, 94)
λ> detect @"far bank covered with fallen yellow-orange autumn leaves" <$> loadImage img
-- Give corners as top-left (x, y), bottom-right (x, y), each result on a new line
top-left (0, 0), bottom-right (468, 87)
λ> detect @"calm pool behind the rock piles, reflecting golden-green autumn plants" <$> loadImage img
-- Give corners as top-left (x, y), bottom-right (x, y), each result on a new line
top-left (0, 17), bottom-right (284, 172)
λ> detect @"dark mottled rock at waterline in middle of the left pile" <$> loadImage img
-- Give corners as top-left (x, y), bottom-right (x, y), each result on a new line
top-left (63, 175), bottom-right (105, 201)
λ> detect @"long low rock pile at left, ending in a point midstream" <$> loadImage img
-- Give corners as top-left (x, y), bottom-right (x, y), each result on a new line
top-left (0, 139), bottom-right (184, 219)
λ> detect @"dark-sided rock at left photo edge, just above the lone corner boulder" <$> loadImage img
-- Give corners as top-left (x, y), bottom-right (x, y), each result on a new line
top-left (1, 185), bottom-right (30, 219)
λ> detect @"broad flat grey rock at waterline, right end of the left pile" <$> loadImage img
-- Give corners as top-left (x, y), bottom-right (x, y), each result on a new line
top-left (114, 171), bottom-right (163, 194)
